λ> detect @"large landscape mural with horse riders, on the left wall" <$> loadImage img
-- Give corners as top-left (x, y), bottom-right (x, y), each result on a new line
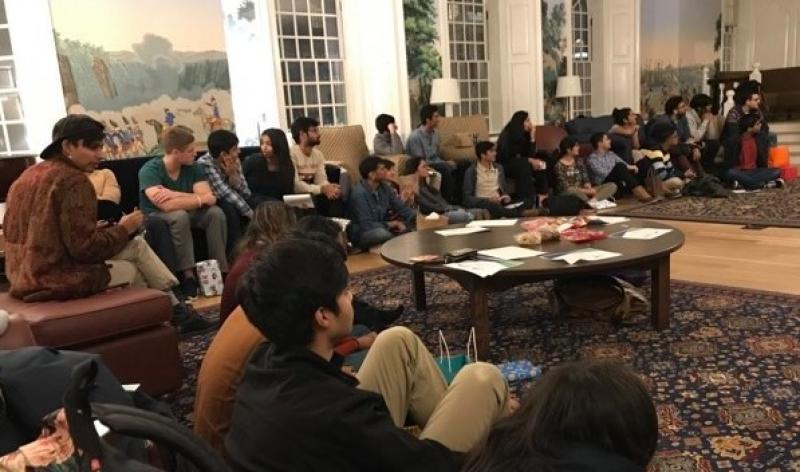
top-left (50, 0), bottom-right (234, 159)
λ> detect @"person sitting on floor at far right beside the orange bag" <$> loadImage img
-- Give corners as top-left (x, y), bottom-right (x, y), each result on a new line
top-left (722, 112), bottom-right (784, 190)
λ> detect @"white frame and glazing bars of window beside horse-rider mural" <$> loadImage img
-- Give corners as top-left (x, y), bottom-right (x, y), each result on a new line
top-left (270, 0), bottom-right (347, 128)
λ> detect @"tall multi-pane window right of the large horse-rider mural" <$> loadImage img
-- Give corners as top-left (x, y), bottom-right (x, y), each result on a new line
top-left (275, 0), bottom-right (347, 125)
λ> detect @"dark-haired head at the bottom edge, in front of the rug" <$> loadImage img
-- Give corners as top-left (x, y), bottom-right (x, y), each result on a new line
top-left (463, 361), bottom-right (658, 472)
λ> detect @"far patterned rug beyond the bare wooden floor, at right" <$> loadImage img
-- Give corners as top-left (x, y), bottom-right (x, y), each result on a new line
top-left (603, 180), bottom-right (800, 228)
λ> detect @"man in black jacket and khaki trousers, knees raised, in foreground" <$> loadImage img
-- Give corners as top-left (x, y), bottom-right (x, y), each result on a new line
top-left (225, 238), bottom-right (514, 471)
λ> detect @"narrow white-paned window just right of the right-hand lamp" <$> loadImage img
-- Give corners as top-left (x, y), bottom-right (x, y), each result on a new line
top-left (572, 0), bottom-right (592, 116)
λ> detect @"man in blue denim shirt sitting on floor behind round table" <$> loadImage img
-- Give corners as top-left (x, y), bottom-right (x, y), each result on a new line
top-left (348, 156), bottom-right (417, 249)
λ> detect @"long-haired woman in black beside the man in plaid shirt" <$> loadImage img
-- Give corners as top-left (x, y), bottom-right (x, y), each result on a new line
top-left (242, 128), bottom-right (296, 204)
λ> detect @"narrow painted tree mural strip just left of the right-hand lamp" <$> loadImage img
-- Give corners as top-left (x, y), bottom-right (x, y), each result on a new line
top-left (542, 0), bottom-right (568, 123)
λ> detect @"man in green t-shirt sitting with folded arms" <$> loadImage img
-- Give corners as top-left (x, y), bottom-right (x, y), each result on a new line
top-left (139, 126), bottom-right (228, 297)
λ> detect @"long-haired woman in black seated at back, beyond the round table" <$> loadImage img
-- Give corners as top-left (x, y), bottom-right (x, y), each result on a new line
top-left (497, 110), bottom-right (550, 205)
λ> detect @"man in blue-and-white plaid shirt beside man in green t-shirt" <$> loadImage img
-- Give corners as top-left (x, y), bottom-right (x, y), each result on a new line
top-left (197, 130), bottom-right (253, 255)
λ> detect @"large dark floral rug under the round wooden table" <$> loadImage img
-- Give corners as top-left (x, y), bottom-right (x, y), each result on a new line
top-left (167, 267), bottom-right (800, 472)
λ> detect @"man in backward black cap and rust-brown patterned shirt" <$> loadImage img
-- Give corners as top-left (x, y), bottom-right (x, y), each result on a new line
top-left (3, 115), bottom-right (212, 330)
